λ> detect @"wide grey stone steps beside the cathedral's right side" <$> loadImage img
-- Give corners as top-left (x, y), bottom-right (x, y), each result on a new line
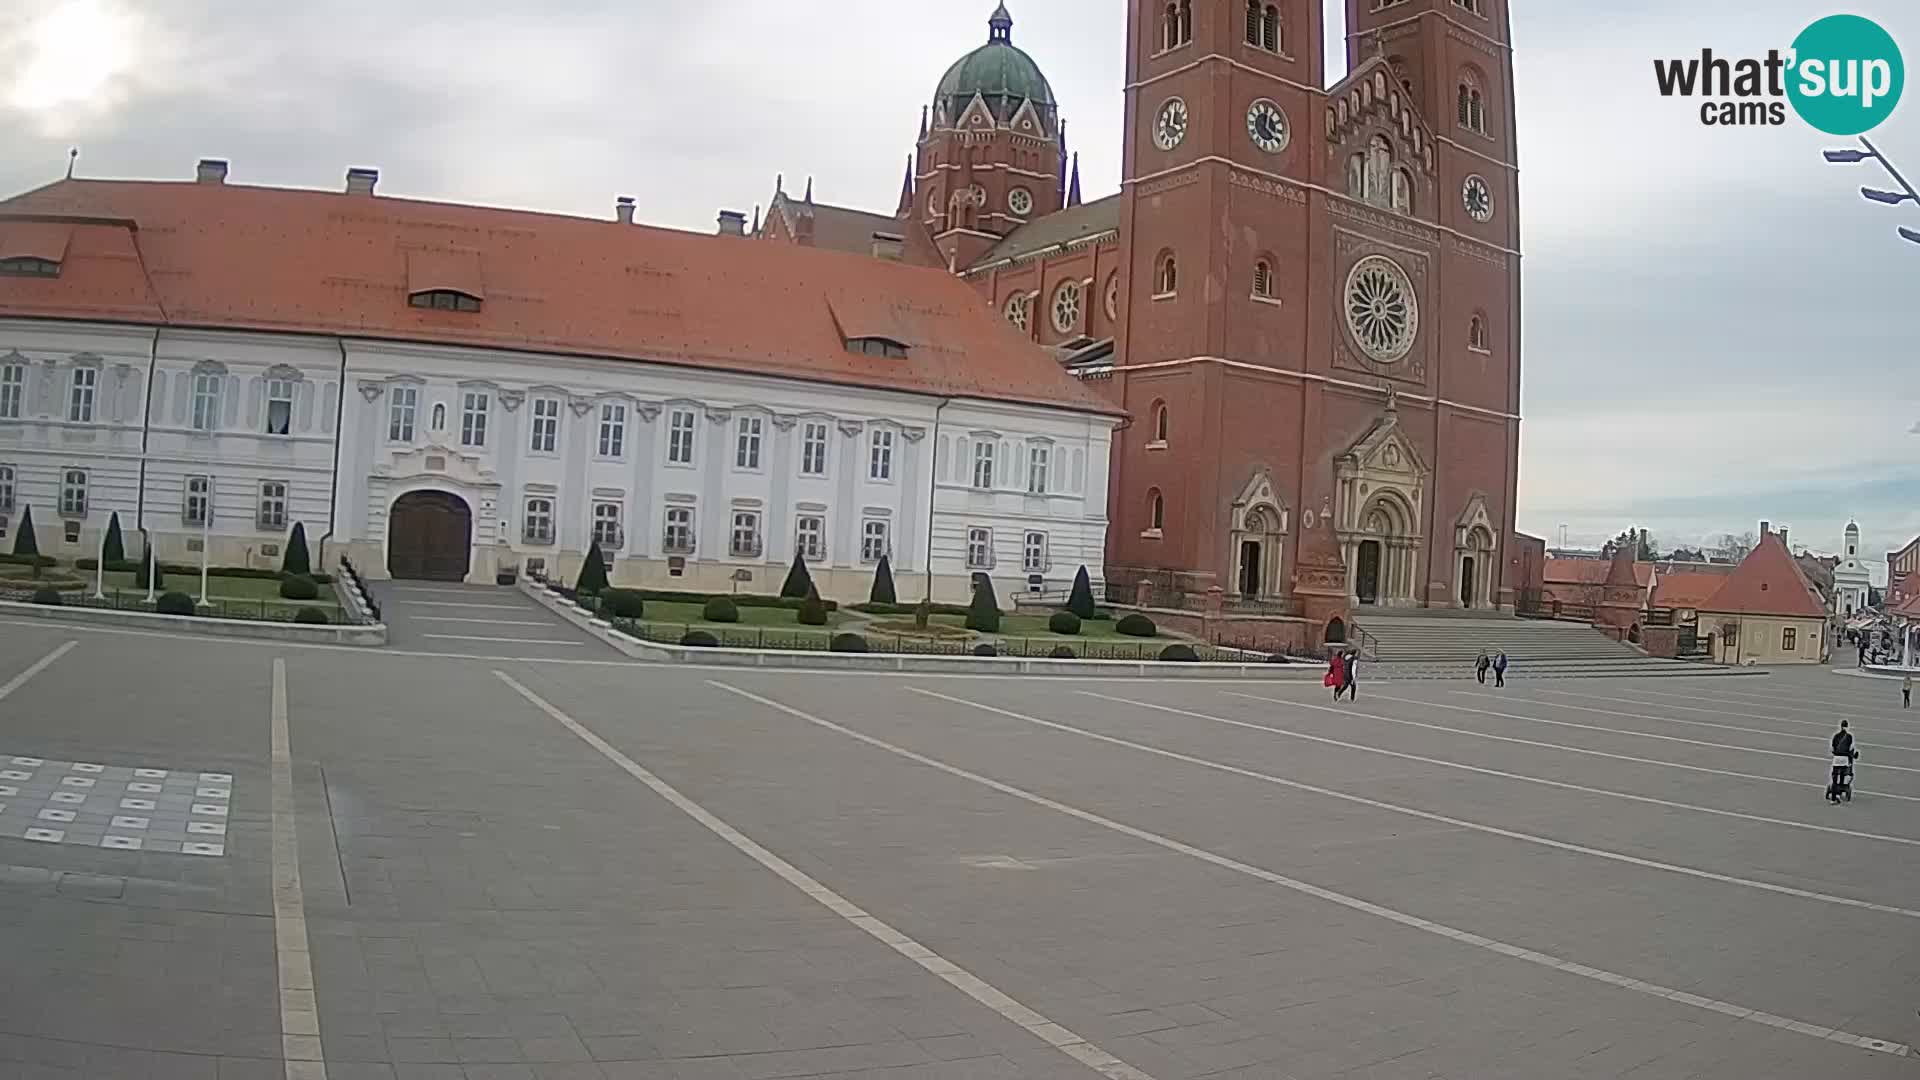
top-left (1356, 609), bottom-right (1751, 678)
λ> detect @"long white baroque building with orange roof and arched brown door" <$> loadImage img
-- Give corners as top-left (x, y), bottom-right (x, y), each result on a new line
top-left (0, 161), bottom-right (1121, 601)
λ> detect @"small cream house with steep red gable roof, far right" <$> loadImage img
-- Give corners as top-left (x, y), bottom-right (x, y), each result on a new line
top-left (1699, 521), bottom-right (1826, 665)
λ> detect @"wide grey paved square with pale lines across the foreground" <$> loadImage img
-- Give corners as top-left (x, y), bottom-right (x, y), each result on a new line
top-left (0, 621), bottom-right (1920, 1080)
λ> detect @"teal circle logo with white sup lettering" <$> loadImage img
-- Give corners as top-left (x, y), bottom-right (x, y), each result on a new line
top-left (1788, 15), bottom-right (1907, 135)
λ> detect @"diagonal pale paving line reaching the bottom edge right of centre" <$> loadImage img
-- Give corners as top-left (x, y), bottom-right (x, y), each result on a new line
top-left (495, 671), bottom-right (1154, 1080)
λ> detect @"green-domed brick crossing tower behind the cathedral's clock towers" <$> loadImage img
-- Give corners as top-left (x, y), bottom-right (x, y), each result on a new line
top-left (912, 4), bottom-right (1066, 269)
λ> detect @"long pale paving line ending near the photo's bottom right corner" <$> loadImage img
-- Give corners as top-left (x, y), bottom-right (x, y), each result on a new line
top-left (708, 680), bottom-right (1912, 1057)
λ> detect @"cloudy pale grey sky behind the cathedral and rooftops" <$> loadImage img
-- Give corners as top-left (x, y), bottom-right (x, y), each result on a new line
top-left (0, 0), bottom-right (1920, 571)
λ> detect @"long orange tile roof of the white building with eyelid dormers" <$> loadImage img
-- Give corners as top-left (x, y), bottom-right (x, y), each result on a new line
top-left (0, 181), bottom-right (1119, 415)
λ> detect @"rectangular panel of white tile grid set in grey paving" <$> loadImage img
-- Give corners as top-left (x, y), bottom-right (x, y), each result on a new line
top-left (0, 753), bottom-right (232, 855)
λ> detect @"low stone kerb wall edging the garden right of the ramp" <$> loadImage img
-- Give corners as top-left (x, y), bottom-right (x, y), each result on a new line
top-left (520, 580), bottom-right (1321, 680)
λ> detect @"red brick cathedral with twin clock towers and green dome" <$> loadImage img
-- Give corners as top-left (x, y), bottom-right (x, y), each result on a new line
top-left (760, 0), bottom-right (1521, 619)
